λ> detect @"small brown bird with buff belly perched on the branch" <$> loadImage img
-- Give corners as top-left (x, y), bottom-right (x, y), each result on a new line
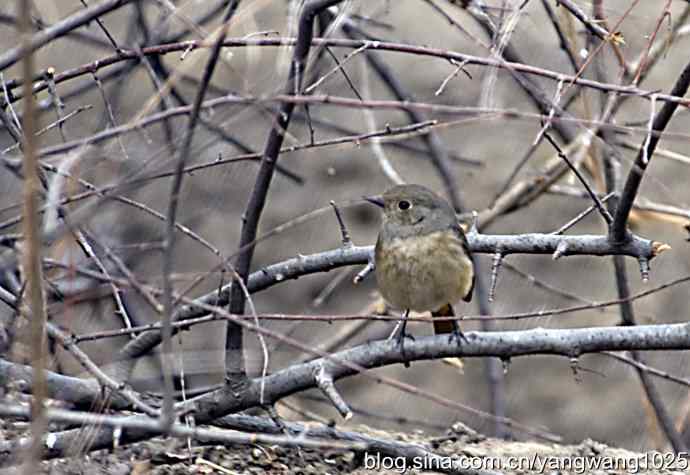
top-left (365, 185), bottom-right (474, 345)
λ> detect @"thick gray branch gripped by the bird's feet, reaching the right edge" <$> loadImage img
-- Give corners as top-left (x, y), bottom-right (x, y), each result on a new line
top-left (191, 323), bottom-right (690, 423)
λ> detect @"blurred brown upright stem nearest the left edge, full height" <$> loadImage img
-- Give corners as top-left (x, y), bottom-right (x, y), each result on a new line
top-left (17, 0), bottom-right (47, 474)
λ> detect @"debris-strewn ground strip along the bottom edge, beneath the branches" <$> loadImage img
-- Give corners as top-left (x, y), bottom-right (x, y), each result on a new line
top-left (5, 426), bottom-right (686, 475)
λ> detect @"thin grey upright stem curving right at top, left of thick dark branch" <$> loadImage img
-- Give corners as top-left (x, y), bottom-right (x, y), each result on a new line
top-left (161, 0), bottom-right (239, 430)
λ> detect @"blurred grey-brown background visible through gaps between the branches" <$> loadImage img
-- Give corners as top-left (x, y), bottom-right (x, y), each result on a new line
top-left (0, 0), bottom-right (690, 456)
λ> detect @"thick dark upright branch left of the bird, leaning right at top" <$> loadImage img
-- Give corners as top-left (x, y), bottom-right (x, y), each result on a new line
top-left (225, 0), bottom-right (341, 381)
